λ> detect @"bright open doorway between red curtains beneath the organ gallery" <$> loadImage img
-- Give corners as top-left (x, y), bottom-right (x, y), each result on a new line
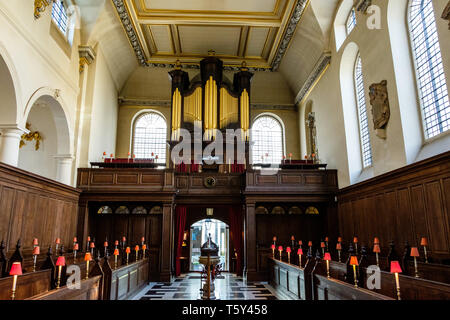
top-left (189, 219), bottom-right (230, 271)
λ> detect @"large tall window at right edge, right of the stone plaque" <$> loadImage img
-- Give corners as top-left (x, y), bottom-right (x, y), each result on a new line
top-left (409, 0), bottom-right (450, 139)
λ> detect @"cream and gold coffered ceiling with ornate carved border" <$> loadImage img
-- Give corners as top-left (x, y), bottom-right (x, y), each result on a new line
top-left (112, 0), bottom-right (309, 70)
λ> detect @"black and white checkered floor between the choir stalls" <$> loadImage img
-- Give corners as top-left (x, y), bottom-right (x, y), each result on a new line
top-left (133, 273), bottom-right (284, 300)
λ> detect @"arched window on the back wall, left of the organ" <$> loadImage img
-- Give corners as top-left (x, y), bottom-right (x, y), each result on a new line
top-left (133, 112), bottom-right (167, 163)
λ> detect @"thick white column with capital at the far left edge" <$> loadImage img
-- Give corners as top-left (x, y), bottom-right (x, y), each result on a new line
top-left (0, 126), bottom-right (27, 167)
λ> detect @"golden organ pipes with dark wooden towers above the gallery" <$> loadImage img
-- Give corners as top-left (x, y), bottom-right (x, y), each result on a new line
top-left (169, 51), bottom-right (253, 141)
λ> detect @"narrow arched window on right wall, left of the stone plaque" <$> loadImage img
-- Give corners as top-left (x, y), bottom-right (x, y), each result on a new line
top-left (355, 54), bottom-right (372, 168)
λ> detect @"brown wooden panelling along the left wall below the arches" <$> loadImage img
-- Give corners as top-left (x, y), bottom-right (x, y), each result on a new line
top-left (0, 163), bottom-right (81, 255)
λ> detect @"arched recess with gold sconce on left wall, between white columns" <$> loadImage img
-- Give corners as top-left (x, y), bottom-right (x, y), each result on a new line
top-left (18, 95), bottom-right (73, 185)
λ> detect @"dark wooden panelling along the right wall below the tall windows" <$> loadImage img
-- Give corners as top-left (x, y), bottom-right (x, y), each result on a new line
top-left (338, 152), bottom-right (450, 262)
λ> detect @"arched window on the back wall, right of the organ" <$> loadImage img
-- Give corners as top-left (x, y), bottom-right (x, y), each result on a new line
top-left (251, 115), bottom-right (284, 164)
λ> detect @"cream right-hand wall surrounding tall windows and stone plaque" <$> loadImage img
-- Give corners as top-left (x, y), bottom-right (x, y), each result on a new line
top-left (300, 0), bottom-right (450, 188)
